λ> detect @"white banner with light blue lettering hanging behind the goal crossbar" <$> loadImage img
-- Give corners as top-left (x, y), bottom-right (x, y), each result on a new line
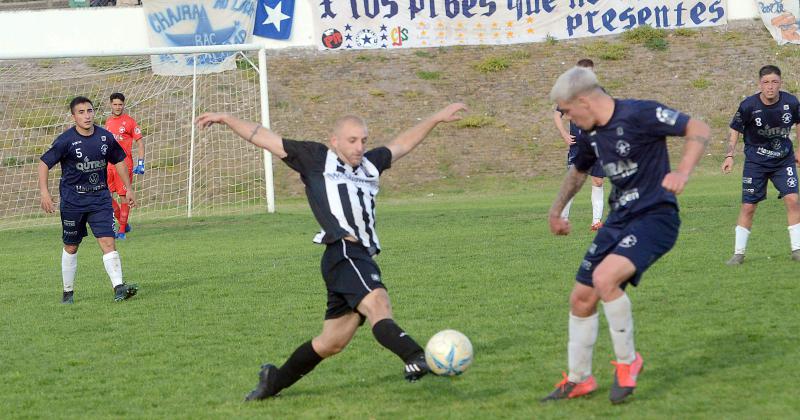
top-left (143, 0), bottom-right (256, 76)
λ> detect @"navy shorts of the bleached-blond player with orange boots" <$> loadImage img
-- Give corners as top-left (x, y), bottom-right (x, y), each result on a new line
top-left (575, 206), bottom-right (681, 289)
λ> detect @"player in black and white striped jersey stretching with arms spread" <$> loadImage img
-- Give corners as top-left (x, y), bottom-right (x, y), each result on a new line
top-left (197, 104), bottom-right (465, 401)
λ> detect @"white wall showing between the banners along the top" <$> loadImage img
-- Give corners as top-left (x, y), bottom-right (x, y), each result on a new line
top-left (0, 0), bottom-right (758, 57)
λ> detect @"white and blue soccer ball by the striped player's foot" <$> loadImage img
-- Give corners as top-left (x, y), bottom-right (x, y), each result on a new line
top-left (425, 330), bottom-right (472, 376)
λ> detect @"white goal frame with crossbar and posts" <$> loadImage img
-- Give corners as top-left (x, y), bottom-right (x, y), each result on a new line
top-left (0, 44), bottom-right (275, 226)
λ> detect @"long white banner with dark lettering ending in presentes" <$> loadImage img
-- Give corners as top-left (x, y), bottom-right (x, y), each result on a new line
top-left (314, 0), bottom-right (728, 50)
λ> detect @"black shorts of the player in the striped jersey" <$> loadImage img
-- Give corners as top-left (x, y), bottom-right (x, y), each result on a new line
top-left (320, 239), bottom-right (386, 322)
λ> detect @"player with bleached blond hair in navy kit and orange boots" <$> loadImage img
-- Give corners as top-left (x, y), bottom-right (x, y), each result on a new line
top-left (544, 67), bottom-right (710, 404)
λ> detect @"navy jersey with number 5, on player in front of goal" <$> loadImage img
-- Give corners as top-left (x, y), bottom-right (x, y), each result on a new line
top-left (41, 125), bottom-right (125, 211)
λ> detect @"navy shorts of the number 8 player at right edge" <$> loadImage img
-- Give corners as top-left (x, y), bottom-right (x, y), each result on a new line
top-left (742, 156), bottom-right (798, 204)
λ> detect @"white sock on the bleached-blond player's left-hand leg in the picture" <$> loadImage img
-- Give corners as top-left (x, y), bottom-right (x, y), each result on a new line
top-left (567, 312), bottom-right (600, 384)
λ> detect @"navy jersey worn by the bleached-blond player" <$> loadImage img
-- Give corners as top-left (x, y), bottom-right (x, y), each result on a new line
top-left (575, 99), bottom-right (689, 223)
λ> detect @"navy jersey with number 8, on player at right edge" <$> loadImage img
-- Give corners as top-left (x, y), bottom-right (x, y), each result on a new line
top-left (730, 92), bottom-right (800, 168)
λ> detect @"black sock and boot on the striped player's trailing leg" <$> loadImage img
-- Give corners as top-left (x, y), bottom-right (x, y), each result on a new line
top-left (244, 341), bottom-right (323, 401)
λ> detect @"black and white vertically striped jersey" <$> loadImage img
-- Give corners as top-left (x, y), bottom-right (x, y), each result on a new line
top-left (283, 139), bottom-right (392, 255)
